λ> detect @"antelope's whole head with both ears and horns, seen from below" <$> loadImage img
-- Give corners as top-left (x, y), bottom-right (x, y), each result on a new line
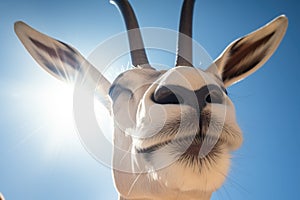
top-left (15, 0), bottom-right (287, 199)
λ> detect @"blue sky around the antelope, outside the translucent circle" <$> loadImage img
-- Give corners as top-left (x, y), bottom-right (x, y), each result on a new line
top-left (0, 0), bottom-right (300, 200)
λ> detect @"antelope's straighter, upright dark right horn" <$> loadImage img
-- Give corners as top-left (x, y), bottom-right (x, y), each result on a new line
top-left (176, 0), bottom-right (195, 67)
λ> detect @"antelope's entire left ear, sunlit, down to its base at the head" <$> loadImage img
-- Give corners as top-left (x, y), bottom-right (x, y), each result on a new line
top-left (15, 22), bottom-right (111, 110)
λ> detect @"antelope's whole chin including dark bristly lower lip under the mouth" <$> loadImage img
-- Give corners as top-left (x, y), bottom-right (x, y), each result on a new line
top-left (135, 124), bottom-right (240, 192)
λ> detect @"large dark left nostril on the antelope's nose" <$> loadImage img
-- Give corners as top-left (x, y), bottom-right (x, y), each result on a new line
top-left (152, 86), bottom-right (180, 104)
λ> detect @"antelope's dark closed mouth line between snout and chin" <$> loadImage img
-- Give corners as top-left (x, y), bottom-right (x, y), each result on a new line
top-left (136, 133), bottom-right (220, 157)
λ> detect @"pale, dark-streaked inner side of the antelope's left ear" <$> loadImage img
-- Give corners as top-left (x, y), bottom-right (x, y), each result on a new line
top-left (15, 22), bottom-right (85, 81)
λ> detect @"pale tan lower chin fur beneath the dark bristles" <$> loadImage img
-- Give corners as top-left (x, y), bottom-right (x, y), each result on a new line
top-left (158, 151), bottom-right (230, 192)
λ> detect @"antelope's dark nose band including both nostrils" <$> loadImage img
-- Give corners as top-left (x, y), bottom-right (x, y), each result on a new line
top-left (152, 85), bottom-right (224, 109)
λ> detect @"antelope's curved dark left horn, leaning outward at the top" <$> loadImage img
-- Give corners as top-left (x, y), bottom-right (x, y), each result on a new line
top-left (110, 0), bottom-right (152, 68)
